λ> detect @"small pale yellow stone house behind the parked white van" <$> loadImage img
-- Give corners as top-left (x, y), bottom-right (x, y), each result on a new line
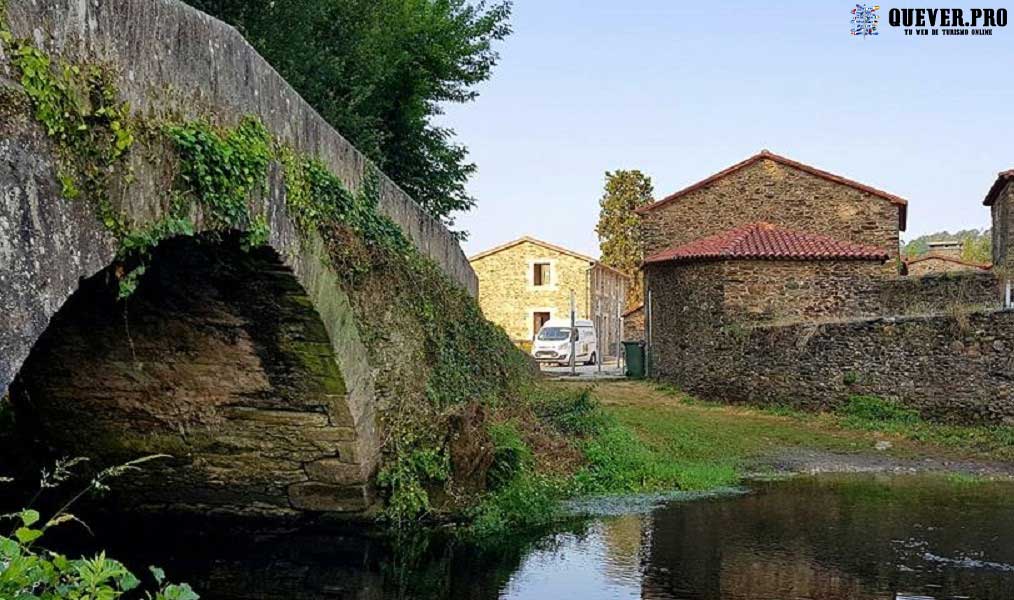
top-left (469, 236), bottom-right (630, 356)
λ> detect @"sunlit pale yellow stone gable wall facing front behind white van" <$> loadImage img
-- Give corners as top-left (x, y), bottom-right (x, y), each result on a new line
top-left (472, 241), bottom-right (592, 342)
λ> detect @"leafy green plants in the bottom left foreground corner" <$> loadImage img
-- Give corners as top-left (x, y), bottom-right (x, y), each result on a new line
top-left (0, 456), bottom-right (198, 600)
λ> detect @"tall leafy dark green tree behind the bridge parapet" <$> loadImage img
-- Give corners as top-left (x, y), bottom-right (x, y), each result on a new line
top-left (188, 0), bottom-right (511, 235)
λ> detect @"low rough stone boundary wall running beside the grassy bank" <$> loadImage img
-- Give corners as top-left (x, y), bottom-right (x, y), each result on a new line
top-left (653, 311), bottom-right (1014, 424)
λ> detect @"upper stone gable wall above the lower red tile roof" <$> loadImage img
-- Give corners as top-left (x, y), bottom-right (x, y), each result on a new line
top-left (642, 159), bottom-right (901, 273)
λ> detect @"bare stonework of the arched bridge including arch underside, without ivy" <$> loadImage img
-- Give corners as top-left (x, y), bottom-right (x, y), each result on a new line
top-left (0, 0), bottom-right (478, 512)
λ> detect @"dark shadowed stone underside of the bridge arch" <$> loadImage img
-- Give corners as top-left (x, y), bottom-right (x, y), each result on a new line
top-left (11, 233), bottom-right (374, 513)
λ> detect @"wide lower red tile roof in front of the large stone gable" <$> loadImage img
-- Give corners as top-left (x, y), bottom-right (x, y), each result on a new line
top-left (644, 223), bottom-right (889, 264)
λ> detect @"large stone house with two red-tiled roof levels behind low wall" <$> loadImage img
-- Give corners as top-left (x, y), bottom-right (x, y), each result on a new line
top-left (637, 150), bottom-right (908, 326)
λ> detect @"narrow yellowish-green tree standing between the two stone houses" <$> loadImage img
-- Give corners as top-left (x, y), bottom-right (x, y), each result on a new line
top-left (595, 170), bottom-right (654, 307)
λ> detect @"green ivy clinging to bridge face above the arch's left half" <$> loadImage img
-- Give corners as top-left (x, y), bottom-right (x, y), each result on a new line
top-left (0, 21), bottom-right (274, 298)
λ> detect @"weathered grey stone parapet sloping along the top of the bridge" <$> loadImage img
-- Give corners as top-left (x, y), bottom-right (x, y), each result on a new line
top-left (0, 0), bottom-right (478, 295)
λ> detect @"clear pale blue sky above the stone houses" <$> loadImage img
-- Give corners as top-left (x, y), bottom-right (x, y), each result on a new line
top-left (440, 0), bottom-right (1014, 256)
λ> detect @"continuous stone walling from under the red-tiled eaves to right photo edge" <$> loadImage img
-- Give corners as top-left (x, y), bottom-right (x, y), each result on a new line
top-left (645, 256), bottom-right (1014, 423)
